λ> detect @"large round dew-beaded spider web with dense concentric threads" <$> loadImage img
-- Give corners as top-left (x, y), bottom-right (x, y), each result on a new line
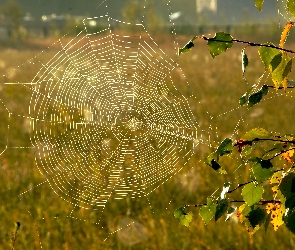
top-left (30, 16), bottom-right (198, 208)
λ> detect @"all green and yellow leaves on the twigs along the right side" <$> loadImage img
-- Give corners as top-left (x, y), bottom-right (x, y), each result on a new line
top-left (174, 0), bottom-right (295, 236)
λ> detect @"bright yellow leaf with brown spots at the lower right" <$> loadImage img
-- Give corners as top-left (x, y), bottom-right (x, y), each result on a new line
top-left (265, 203), bottom-right (285, 231)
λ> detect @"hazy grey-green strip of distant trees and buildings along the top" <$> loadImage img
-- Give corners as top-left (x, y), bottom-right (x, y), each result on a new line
top-left (0, 0), bottom-right (282, 40)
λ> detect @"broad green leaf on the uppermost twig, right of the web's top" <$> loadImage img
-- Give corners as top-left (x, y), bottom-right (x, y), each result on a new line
top-left (208, 32), bottom-right (233, 58)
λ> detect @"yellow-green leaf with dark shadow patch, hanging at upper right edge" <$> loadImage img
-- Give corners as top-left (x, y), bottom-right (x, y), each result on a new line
top-left (270, 53), bottom-right (293, 89)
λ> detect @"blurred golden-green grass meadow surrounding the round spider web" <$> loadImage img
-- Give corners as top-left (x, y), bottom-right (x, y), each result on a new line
top-left (0, 29), bottom-right (295, 250)
